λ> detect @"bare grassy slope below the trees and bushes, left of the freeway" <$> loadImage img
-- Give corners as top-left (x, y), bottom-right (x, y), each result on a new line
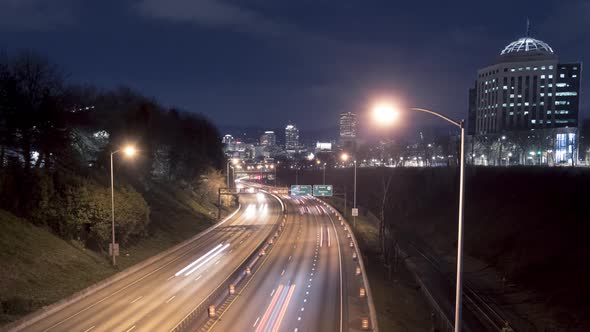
top-left (0, 185), bottom-right (236, 325)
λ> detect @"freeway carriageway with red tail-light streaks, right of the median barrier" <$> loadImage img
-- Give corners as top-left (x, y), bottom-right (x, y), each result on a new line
top-left (209, 198), bottom-right (349, 332)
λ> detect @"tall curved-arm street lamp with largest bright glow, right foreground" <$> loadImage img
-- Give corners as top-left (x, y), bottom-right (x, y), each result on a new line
top-left (373, 104), bottom-right (465, 332)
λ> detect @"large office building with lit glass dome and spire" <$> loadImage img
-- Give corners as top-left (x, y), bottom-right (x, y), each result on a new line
top-left (467, 27), bottom-right (582, 164)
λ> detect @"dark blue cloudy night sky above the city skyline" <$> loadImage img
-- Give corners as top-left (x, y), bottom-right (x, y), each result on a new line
top-left (0, 0), bottom-right (590, 129)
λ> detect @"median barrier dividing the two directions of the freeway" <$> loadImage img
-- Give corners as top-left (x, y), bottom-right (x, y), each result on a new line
top-left (170, 193), bottom-right (287, 332)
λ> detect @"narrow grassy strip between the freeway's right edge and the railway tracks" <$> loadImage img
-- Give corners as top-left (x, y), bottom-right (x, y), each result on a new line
top-left (326, 198), bottom-right (431, 331)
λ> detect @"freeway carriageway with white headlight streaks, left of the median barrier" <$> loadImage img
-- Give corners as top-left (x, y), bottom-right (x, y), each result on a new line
top-left (19, 193), bottom-right (282, 332)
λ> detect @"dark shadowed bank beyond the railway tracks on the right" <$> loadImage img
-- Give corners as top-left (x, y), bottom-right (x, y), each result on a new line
top-left (279, 167), bottom-right (590, 331)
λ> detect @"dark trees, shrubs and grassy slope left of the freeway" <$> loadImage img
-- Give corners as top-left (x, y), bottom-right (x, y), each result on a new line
top-left (0, 52), bottom-right (235, 324)
